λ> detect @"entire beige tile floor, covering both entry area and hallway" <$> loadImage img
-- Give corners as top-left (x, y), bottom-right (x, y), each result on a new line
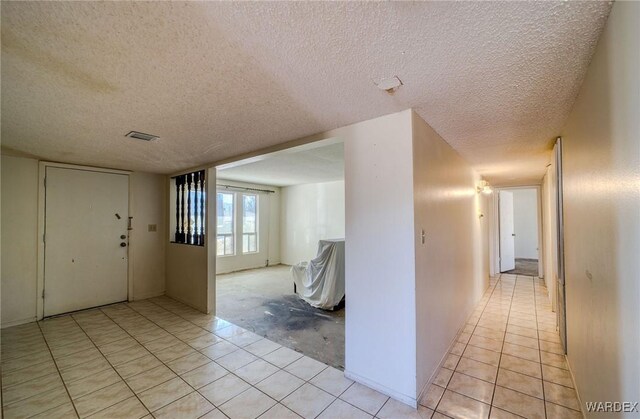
top-left (2, 276), bottom-right (580, 419)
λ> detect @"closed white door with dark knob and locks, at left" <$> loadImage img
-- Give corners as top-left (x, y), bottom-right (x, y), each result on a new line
top-left (44, 167), bottom-right (129, 316)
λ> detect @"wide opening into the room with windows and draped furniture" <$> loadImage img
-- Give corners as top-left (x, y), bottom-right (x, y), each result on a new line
top-left (216, 140), bottom-right (345, 369)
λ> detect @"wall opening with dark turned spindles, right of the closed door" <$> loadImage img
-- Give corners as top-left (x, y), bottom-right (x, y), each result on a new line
top-left (173, 170), bottom-right (206, 246)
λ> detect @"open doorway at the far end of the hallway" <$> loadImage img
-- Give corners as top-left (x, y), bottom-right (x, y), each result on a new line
top-left (498, 187), bottom-right (541, 277)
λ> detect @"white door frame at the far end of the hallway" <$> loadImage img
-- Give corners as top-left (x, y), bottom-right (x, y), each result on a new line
top-left (489, 185), bottom-right (545, 278)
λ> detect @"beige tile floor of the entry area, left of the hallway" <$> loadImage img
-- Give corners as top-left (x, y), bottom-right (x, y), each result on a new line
top-left (2, 297), bottom-right (402, 419)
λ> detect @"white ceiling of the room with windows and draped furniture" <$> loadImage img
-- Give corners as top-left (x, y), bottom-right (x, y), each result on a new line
top-left (218, 143), bottom-right (344, 186)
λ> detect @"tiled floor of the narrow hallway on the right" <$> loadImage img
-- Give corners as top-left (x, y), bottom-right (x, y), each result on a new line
top-left (421, 274), bottom-right (582, 419)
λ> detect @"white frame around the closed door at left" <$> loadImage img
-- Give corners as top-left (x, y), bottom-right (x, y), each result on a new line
top-left (35, 161), bottom-right (133, 320)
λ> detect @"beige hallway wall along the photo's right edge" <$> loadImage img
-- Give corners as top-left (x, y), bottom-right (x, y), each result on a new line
top-left (562, 2), bottom-right (640, 418)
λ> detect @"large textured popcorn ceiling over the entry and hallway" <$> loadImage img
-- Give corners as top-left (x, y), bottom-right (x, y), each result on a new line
top-left (1, 1), bottom-right (610, 183)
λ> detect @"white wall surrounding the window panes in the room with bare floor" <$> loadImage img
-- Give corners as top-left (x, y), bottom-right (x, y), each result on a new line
top-left (216, 179), bottom-right (280, 274)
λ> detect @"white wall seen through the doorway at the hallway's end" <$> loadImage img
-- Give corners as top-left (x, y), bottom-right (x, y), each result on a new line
top-left (510, 189), bottom-right (538, 259)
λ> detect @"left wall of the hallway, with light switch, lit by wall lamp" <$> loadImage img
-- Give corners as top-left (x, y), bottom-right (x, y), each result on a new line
top-left (413, 113), bottom-right (489, 400)
